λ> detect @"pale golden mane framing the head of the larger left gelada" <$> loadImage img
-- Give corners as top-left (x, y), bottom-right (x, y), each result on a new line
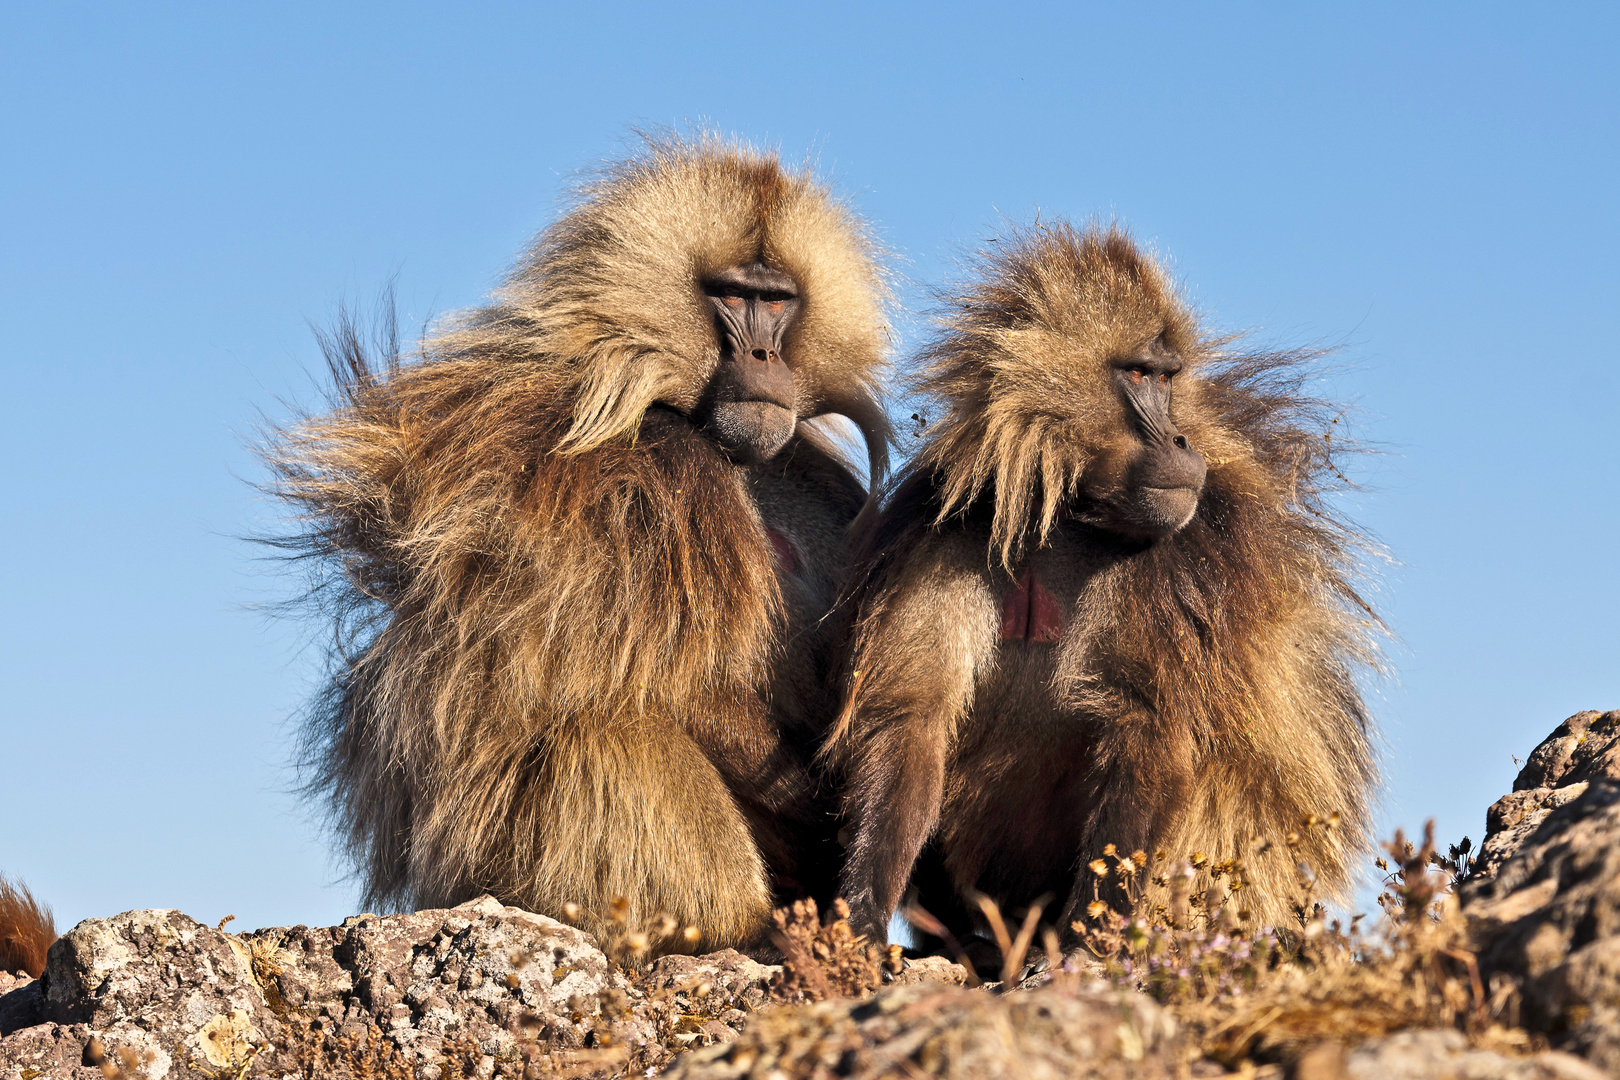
top-left (431, 136), bottom-right (888, 485)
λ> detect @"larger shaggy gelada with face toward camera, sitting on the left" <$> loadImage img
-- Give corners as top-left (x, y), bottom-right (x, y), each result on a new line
top-left (271, 138), bottom-right (889, 949)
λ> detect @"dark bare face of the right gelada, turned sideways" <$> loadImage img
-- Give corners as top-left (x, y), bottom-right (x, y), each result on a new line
top-left (1077, 342), bottom-right (1205, 541)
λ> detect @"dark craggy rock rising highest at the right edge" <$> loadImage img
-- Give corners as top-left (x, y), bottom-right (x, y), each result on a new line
top-left (1463, 711), bottom-right (1620, 1075)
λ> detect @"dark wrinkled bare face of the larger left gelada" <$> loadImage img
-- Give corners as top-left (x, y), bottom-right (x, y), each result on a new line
top-left (692, 262), bottom-right (802, 465)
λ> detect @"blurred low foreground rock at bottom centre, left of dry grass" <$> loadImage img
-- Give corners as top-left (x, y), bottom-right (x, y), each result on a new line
top-left (667, 984), bottom-right (1179, 1080)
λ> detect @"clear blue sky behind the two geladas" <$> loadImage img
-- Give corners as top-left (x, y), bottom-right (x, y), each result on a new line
top-left (0, 3), bottom-right (1620, 926)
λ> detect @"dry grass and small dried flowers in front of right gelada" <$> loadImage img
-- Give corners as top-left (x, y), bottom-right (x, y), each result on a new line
top-left (1048, 821), bottom-right (1533, 1067)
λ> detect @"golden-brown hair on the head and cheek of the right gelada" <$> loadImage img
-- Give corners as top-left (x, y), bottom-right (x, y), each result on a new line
top-left (914, 222), bottom-right (1204, 562)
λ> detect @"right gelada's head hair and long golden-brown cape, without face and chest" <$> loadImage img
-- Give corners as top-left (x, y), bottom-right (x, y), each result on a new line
top-left (833, 223), bottom-right (1382, 918)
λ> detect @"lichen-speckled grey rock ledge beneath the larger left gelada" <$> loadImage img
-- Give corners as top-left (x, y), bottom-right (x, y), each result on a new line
top-left (0, 897), bottom-right (778, 1080)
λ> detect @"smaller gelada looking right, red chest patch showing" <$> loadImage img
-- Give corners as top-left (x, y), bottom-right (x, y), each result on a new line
top-left (828, 223), bottom-right (1375, 941)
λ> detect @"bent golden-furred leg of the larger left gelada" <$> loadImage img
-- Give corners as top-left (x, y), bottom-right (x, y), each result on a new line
top-left (530, 721), bottom-right (771, 952)
